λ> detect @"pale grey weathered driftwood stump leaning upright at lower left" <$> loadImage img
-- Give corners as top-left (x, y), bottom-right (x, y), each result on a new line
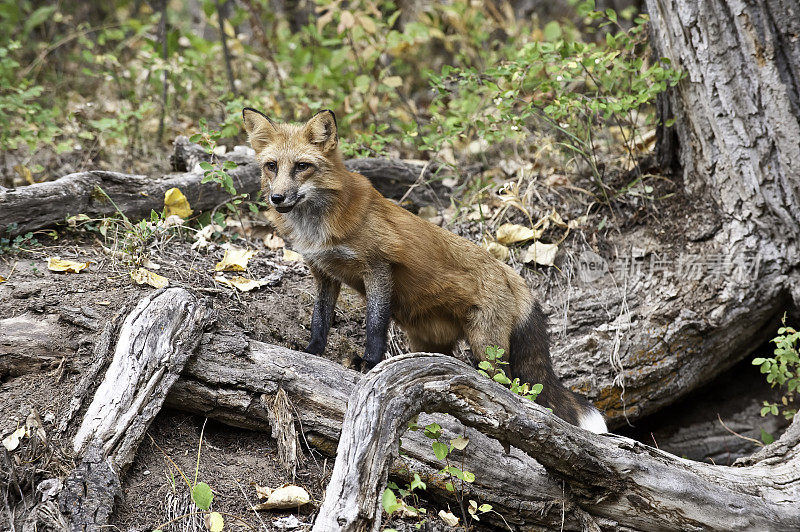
top-left (58, 288), bottom-right (210, 530)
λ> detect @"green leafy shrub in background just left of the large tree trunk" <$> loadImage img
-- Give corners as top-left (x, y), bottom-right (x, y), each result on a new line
top-left (420, 0), bottom-right (682, 200)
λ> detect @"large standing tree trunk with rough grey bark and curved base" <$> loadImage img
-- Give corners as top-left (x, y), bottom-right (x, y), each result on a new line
top-left (540, 0), bottom-right (800, 426)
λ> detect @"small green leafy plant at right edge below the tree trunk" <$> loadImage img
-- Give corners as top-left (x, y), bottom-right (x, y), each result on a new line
top-left (753, 314), bottom-right (800, 419)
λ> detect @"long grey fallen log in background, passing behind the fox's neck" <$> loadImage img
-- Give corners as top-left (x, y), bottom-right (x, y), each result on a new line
top-left (0, 137), bottom-right (443, 236)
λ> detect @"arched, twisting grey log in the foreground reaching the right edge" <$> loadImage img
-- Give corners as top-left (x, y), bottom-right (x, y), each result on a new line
top-left (313, 353), bottom-right (800, 532)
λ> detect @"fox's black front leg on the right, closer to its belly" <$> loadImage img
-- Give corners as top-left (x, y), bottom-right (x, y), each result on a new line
top-left (363, 263), bottom-right (392, 368)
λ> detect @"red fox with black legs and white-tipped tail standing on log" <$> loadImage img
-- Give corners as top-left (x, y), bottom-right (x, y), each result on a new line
top-left (242, 108), bottom-right (607, 432)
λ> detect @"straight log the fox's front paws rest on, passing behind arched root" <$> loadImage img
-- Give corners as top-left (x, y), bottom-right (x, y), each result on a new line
top-left (165, 331), bottom-right (580, 530)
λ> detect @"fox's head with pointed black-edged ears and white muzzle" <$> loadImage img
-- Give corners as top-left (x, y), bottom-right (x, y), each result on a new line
top-left (242, 107), bottom-right (344, 213)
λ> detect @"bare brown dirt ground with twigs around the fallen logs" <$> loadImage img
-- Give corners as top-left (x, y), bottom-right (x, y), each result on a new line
top-left (0, 165), bottom-right (788, 531)
